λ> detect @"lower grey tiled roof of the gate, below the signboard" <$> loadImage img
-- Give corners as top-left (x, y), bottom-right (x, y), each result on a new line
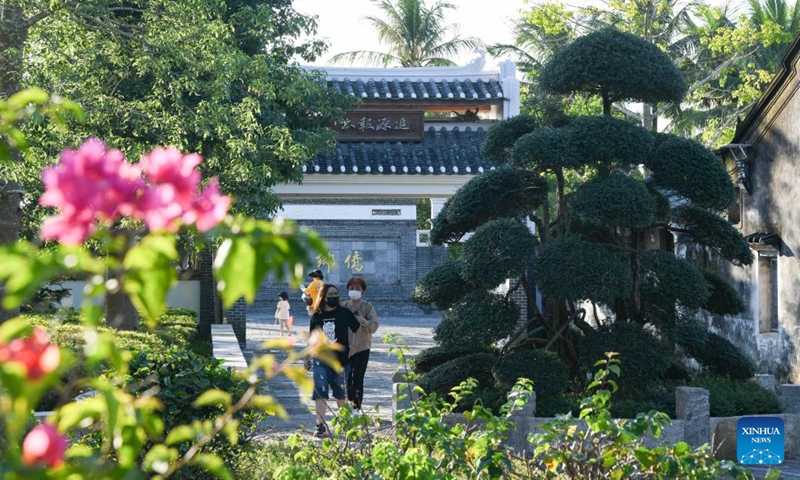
top-left (303, 127), bottom-right (494, 175)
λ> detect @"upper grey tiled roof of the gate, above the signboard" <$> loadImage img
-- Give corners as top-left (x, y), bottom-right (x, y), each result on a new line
top-left (328, 78), bottom-right (503, 100)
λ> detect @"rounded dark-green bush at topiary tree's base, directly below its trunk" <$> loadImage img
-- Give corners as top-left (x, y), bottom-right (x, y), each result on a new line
top-left (493, 350), bottom-right (569, 403)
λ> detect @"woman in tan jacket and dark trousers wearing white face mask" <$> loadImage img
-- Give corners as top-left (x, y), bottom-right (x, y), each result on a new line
top-left (343, 277), bottom-right (379, 415)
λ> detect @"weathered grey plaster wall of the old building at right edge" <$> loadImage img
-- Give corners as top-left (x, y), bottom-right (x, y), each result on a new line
top-left (716, 74), bottom-right (800, 383)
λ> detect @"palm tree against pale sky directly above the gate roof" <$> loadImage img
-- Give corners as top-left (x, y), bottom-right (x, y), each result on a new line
top-left (331, 0), bottom-right (482, 67)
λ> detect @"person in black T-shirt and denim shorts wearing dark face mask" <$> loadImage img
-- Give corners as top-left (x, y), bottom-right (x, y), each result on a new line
top-left (308, 284), bottom-right (361, 437)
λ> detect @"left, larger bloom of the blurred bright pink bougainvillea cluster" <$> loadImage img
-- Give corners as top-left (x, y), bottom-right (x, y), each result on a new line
top-left (39, 138), bottom-right (145, 245)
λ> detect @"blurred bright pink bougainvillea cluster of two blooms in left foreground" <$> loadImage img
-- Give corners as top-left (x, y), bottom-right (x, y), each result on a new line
top-left (39, 138), bottom-right (231, 245)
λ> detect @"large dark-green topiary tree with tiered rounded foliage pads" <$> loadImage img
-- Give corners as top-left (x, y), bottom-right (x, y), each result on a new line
top-left (413, 30), bottom-right (753, 380)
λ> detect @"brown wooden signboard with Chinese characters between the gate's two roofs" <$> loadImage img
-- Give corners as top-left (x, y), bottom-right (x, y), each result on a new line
top-left (334, 109), bottom-right (425, 141)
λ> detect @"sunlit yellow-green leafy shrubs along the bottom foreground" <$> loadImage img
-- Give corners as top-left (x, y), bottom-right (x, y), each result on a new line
top-left (255, 350), bottom-right (749, 480)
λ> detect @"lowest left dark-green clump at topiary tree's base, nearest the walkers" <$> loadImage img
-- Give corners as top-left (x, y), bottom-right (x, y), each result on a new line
top-left (419, 353), bottom-right (497, 396)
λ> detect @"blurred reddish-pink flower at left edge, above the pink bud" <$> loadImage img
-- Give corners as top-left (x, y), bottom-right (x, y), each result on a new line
top-left (0, 328), bottom-right (61, 380)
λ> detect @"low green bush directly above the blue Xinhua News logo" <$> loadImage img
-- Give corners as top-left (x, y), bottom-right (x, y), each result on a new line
top-left (691, 376), bottom-right (781, 417)
